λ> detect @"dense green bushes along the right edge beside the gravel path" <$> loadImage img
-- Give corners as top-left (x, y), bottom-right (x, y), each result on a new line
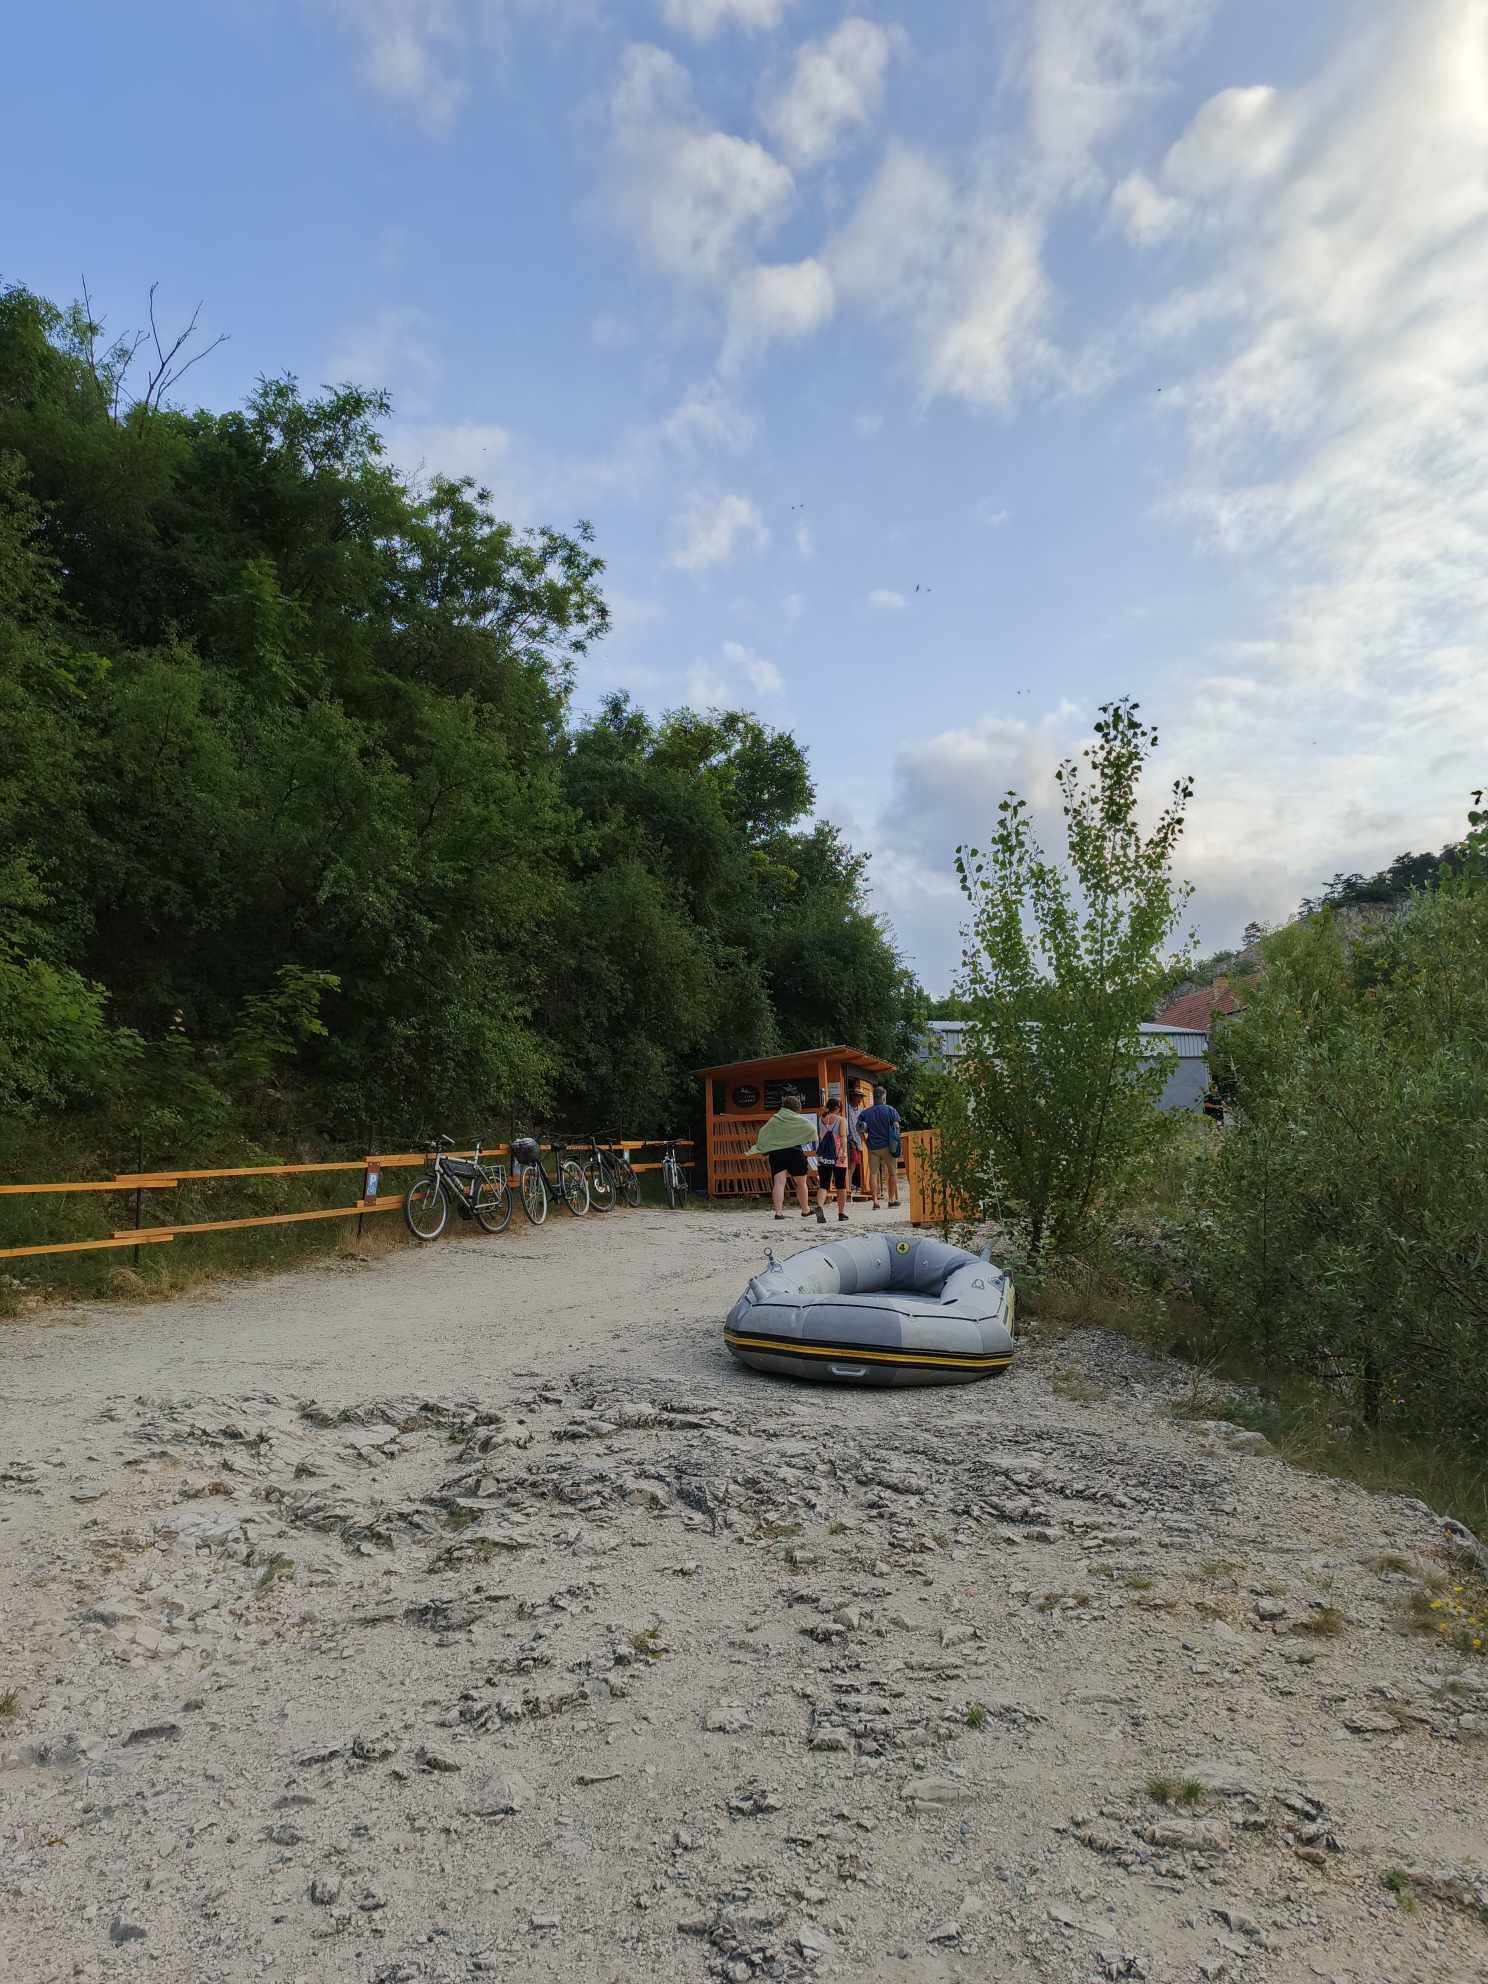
top-left (1190, 815), bottom-right (1488, 1454)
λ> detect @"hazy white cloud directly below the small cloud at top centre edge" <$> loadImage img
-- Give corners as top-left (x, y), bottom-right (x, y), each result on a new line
top-left (609, 42), bottom-right (794, 284)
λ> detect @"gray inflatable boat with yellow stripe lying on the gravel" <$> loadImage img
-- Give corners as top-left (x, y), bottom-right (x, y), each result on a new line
top-left (724, 1234), bottom-right (1014, 1385)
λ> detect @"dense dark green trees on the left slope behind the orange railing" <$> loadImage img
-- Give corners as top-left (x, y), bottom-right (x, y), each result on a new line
top-left (0, 288), bottom-right (917, 1167)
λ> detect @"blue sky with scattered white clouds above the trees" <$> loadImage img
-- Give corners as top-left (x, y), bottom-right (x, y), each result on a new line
top-left (0, 0), bottom-right (1488, 992)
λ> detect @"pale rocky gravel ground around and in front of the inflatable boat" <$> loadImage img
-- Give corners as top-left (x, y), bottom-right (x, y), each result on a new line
top-left (0, 1212), bottom-right (1488, 1984)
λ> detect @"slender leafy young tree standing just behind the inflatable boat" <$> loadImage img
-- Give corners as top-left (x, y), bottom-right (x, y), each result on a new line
top-left (938, 702), bottom-right (1190, 1256)
